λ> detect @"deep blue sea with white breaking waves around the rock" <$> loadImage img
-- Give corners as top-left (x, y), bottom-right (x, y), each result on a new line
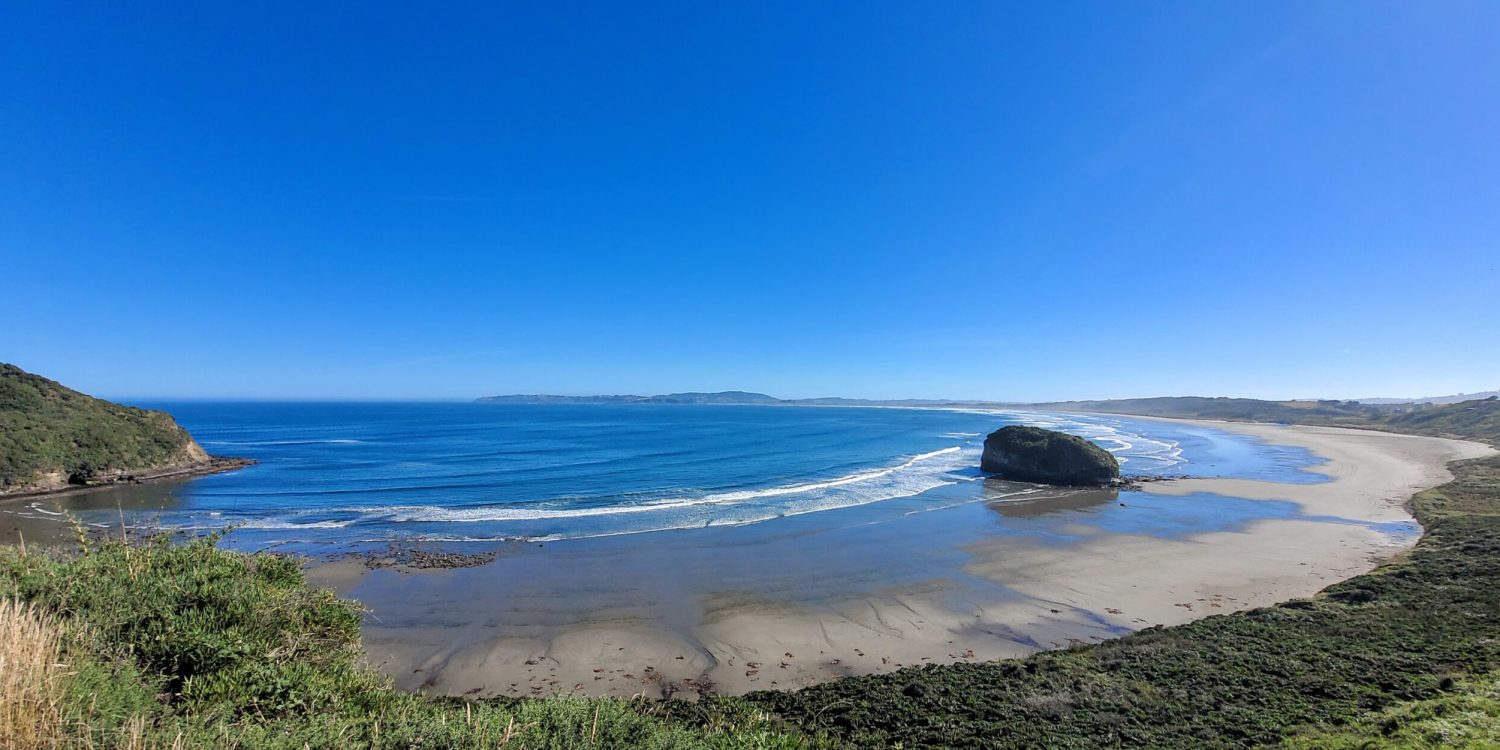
top-left (58, 402), bottom-right (1326, 548)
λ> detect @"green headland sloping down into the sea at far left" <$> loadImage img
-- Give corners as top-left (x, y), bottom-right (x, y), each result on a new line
top-left (0, 363), bottom-right (222, 495)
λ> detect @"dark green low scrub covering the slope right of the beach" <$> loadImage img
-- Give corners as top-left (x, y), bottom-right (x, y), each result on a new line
top-left (729, 401), bottom-right (1500, 749)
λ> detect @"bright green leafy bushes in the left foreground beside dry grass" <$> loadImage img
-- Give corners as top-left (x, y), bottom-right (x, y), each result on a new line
top-left (0, 539), bottom-right (816, 750)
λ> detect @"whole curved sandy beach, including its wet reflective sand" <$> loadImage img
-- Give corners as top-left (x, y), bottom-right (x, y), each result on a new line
top-left (298, 420), bottom-right (1491, 696)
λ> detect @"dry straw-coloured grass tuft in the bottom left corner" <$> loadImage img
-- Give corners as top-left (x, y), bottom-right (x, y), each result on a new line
top-left (0, 599), bottom-right (68, 750)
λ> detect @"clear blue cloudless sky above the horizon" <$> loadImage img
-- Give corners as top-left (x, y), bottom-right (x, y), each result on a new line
top-left (0, 2), bottom-right (1500, 399)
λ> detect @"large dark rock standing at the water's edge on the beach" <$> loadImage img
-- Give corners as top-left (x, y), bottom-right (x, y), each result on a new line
top-left (980, 425), bottom-right (1121, 486)
